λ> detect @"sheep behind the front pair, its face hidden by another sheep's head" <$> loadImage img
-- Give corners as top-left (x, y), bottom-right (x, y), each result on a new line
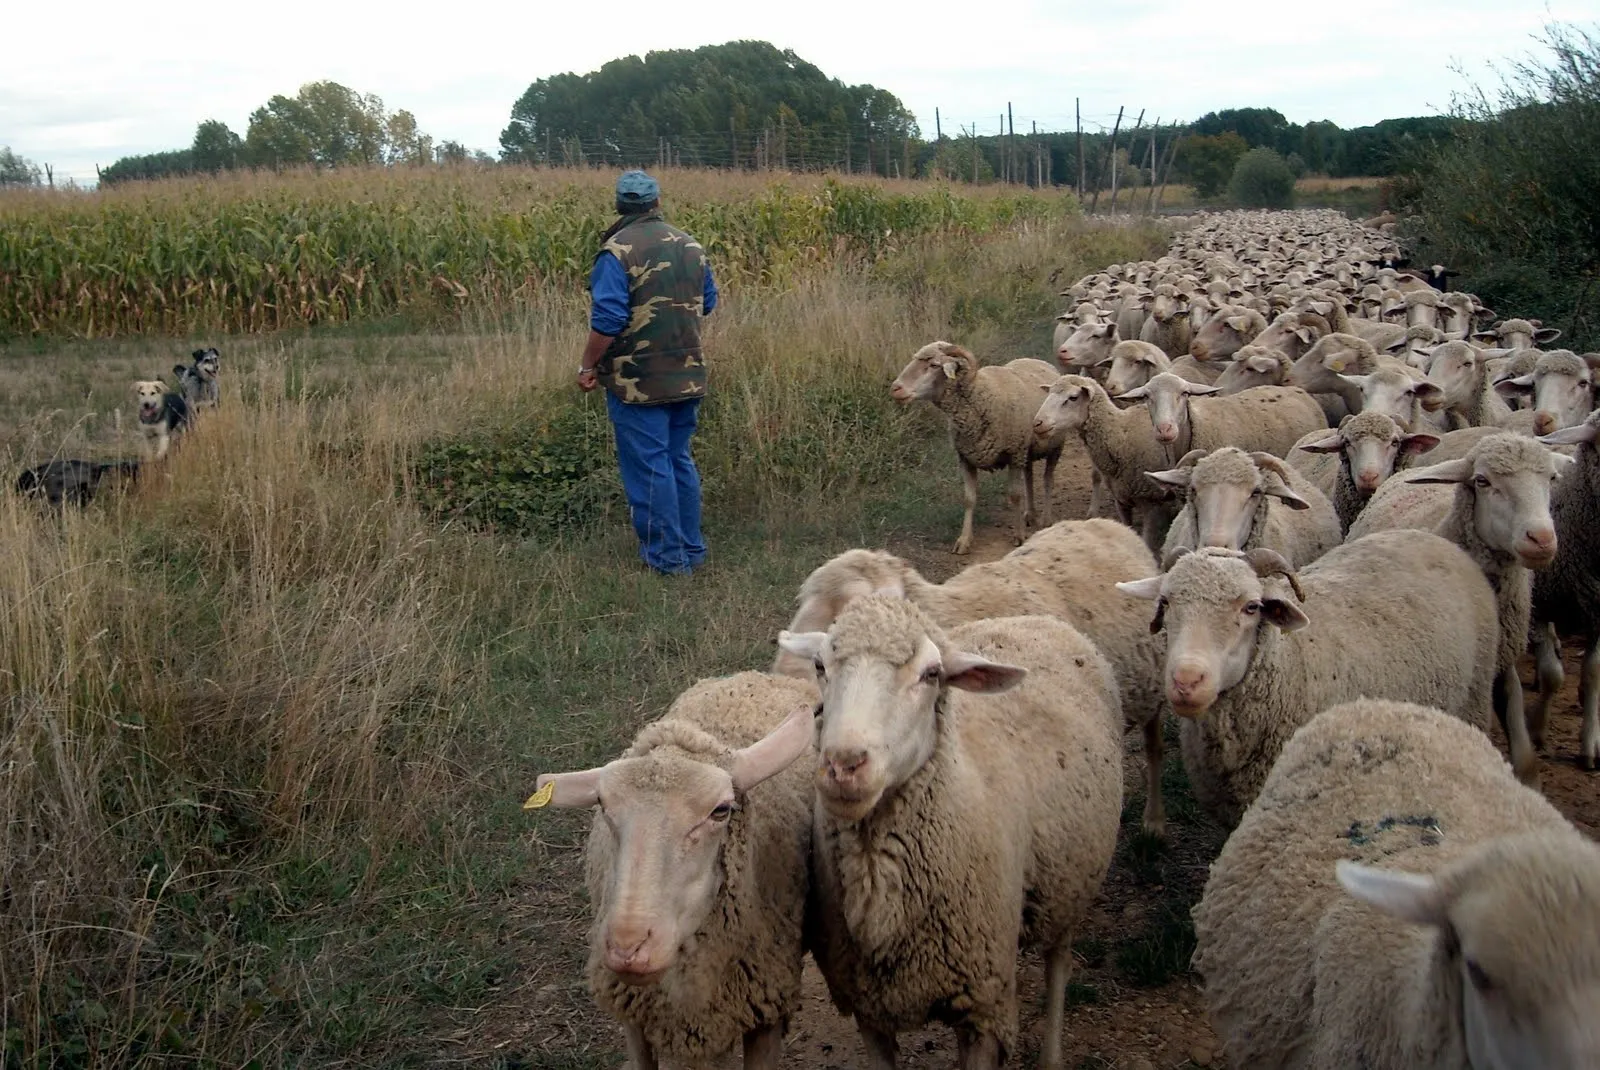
top-left (773, 518), bottom-right (1166, 836)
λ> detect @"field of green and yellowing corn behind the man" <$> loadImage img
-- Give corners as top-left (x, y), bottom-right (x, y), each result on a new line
top-left (0, 166), bottom-right (1077, 337)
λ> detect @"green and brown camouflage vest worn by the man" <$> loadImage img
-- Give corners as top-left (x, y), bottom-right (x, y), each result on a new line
top-left (598, 213), bottom-right (706, 405)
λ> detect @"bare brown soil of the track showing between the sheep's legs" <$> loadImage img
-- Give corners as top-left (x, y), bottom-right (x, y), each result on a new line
top-left (476, 438), bottom-right (1600, 1070)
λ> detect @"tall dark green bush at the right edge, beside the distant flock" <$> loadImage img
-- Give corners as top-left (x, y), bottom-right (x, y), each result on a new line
top-left (1405, 26), bottom-right (1600, 350)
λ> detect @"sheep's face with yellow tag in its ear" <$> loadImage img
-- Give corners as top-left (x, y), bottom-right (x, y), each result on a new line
top-left (536, 709), bottom-right (811, 985)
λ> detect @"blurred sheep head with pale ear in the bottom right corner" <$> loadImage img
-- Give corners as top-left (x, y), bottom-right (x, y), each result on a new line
top-left (1338, 835), bottom-right (1600, 1070)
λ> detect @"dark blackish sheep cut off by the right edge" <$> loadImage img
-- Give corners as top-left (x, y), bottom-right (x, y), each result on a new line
top-left (1528, 413), bottom-right (1600, 769)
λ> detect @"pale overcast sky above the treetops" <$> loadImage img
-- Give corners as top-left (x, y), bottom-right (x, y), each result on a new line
top-left (0, 0), bottom-right (1600, 181)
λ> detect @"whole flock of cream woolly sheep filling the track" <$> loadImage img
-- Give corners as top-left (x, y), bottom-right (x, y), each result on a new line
top-left (528, 213), bottom-right (1600, 1070)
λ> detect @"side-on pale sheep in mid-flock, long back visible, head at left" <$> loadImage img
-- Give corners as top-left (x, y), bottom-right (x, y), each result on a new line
top-left (1120, 373), bottom-right (1328, 457)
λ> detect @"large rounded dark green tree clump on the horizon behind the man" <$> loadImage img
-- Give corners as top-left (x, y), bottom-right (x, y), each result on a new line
top-left (501, 42), bottom-right (917, 171)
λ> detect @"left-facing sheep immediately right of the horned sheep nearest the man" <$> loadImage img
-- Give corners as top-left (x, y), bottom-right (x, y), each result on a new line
top-left (1034, 376), bottom-right (1176, 553)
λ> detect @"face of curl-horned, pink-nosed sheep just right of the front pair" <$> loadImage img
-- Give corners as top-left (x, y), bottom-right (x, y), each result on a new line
top-left (1117, 549), bottom-right (1307, 718)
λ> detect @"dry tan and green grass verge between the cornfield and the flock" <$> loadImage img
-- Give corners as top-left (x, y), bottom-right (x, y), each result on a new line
top-left (0, 204), bottom-right (1163, 1067)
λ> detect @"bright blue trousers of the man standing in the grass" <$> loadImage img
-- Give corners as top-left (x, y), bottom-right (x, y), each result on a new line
top-left (605, 393), bottom-right (706, 573)
